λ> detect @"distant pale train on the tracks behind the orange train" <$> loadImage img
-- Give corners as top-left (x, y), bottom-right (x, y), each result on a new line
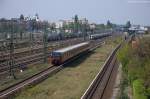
top-left (89, 33), bottom-right (111, 40)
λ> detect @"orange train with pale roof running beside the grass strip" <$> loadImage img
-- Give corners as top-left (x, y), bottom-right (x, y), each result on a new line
top-left (51, 42), bottom-right (90, 66)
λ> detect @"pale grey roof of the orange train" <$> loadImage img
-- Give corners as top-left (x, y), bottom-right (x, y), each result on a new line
top-left (54, 42), bottom-right (89, 53)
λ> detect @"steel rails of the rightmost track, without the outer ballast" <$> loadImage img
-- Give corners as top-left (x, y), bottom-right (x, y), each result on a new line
top-left (81, 44), bottom-right (121, 99)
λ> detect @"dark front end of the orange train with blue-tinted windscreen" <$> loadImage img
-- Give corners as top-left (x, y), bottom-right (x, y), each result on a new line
top-left (51, 51), bottom-right (61, 66)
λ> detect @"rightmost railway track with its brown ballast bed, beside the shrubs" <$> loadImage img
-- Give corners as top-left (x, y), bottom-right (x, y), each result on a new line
top-left (81, 44), bottom-right (121, 99)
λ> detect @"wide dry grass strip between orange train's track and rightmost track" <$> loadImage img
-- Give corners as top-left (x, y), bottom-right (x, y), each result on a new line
top-left (15, 37), bottom-right (120, 99)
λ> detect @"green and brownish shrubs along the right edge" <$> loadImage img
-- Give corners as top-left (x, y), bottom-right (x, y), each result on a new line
top-left (118, 37), bottom-right (150, 99)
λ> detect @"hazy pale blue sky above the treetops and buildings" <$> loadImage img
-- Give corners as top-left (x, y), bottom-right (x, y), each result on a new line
top-left (0, 0), bottom-right (150, 25)
